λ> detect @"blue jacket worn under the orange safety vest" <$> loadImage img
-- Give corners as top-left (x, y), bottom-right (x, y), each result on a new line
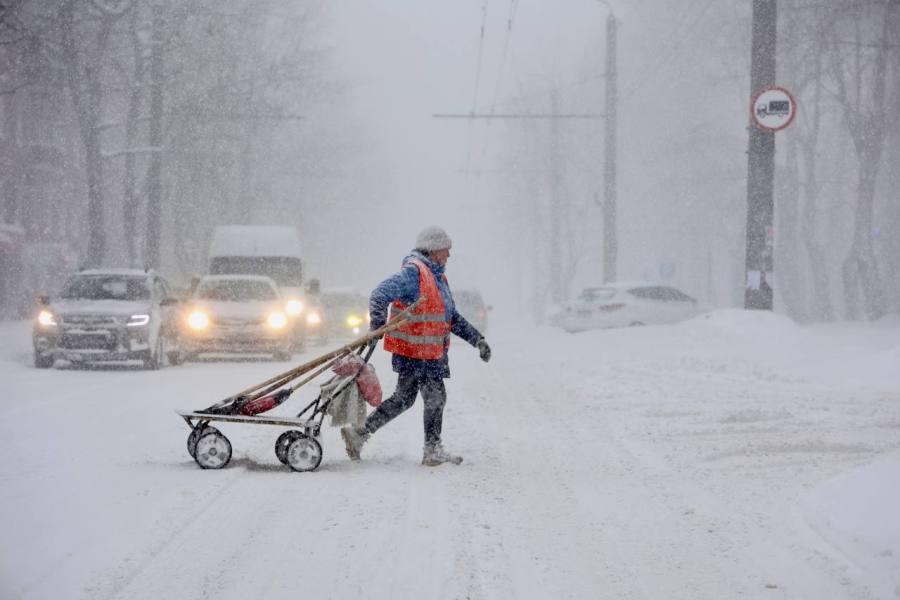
top-left (369, 250), bottom-right (484, 377)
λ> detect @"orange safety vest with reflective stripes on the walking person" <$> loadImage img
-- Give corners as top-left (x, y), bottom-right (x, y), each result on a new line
top-left (384, 258), bottom-right (450, 360)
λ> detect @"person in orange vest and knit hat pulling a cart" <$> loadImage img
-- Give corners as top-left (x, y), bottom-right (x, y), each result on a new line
top-left (341, 227), bottom-right (491, 467)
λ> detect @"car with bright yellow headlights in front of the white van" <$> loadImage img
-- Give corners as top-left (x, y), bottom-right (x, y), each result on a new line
top-left (182, 275), bottom-right (294, 360)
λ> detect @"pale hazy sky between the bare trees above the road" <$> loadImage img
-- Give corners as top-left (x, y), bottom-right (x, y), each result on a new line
top-left (326, 0), bottom-right (746, 314)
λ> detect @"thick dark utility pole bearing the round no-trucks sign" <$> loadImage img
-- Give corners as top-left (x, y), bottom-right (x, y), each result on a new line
top-left (744, 0), bottom-right (778, 310)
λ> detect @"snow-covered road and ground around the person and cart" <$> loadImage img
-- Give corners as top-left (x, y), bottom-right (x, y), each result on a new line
top-left (0, 311), bottom-right (900, 600)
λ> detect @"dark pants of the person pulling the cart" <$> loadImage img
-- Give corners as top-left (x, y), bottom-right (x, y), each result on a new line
top-left (366, 371), bottom-right (447, 444)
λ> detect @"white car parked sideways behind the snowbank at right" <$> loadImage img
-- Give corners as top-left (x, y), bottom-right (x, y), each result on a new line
top-left (551, 283), bottom-right (704, 333)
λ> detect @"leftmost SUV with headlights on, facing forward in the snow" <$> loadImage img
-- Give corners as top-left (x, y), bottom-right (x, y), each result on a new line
top-left (32, 269), bottom-right (181, 369)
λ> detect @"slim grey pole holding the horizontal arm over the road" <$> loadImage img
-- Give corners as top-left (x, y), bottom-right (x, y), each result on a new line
top-left (603, 8), bottom-right (619, 283)
